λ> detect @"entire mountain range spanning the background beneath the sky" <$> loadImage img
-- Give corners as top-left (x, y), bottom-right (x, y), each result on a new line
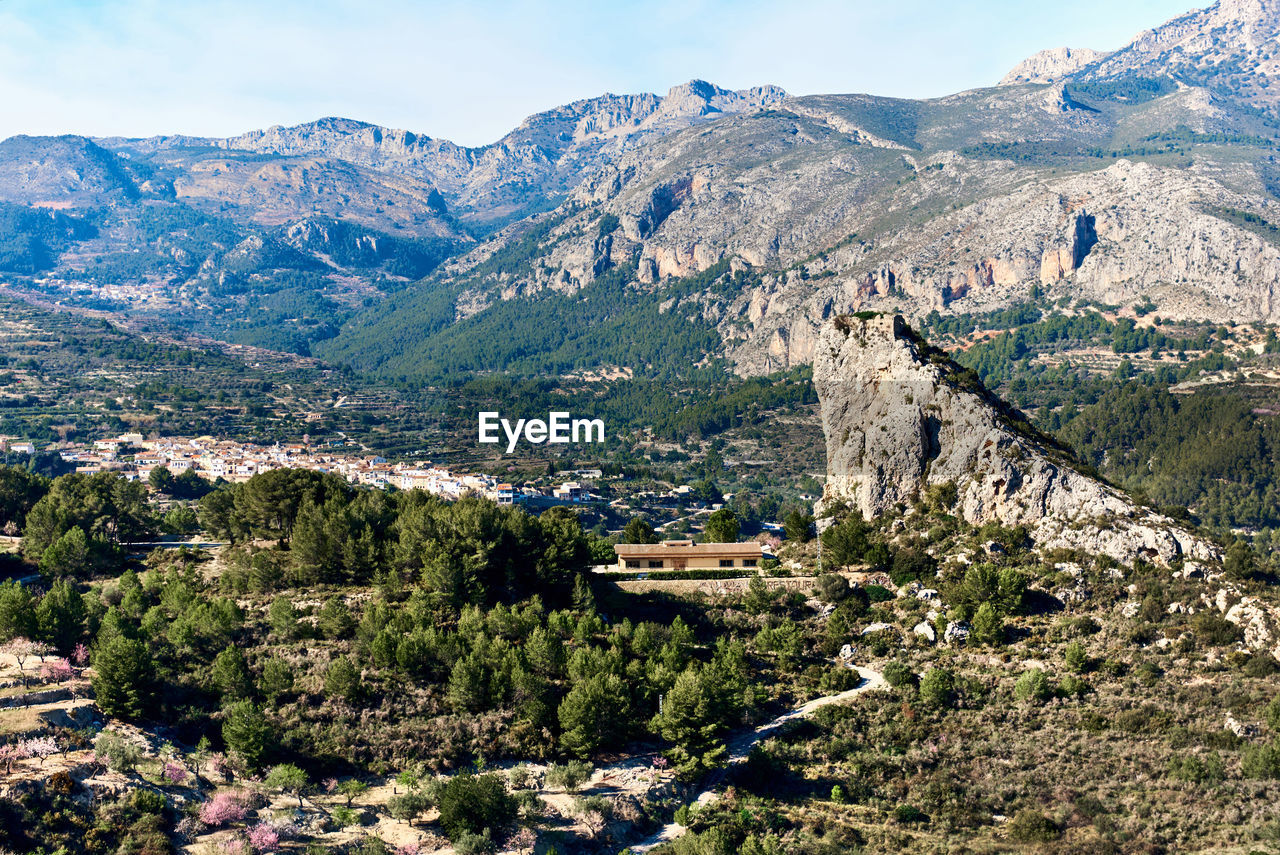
top-left (0, 0), bottom-right (1280, 378)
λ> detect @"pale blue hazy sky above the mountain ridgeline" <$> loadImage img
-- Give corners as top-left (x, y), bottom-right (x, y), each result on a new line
top-left (0, 0), bottom-right (1204, 145)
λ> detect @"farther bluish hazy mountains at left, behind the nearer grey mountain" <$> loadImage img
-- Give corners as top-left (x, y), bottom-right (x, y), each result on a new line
top-left (0, 81), bottom-right (786, 352)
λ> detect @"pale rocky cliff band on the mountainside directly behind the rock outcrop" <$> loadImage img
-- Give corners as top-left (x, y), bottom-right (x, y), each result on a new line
top-left (731, 161), bottom-right (1280, 372)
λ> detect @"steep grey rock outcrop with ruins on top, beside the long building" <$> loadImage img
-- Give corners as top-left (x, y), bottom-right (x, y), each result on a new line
top-left (814, 315), bottom-right (1216, 563)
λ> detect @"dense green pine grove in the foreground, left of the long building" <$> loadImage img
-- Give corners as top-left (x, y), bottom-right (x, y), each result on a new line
top-left (0, 468), bottom-right (865, 851)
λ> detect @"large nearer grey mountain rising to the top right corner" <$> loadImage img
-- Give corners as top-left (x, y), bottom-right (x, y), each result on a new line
top-left (324, 0), bottom-right (1280, 372)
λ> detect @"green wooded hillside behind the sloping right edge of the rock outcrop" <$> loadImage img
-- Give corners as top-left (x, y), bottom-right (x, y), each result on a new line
top-left (925, 305), bottom-right (1280, 537)
